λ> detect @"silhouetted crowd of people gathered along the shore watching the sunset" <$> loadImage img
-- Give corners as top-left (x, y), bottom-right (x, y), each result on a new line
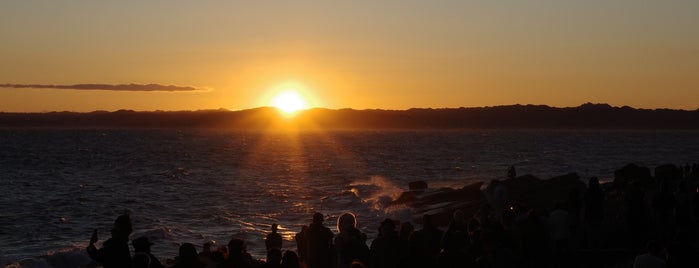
top-left (87, 163), bottom-right (699, 268)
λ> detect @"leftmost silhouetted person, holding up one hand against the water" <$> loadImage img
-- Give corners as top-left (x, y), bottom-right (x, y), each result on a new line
top-left (87, 214), bottom-right (133, 268)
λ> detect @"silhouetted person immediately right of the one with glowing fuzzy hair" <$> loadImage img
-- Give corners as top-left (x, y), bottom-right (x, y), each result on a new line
top-left (369, 219), bottom-right (400, 268)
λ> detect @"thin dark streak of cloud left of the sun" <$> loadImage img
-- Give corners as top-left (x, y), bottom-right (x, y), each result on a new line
top-left (0, 84), bottom-right (207, 92)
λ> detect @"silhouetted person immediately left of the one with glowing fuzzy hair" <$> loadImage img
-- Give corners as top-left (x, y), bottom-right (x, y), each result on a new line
top-left (304, 213), bottom-right (333, 268)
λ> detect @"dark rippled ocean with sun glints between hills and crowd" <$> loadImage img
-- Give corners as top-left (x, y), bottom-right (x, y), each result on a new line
top-left (0, 128), bottom-right (699, 267)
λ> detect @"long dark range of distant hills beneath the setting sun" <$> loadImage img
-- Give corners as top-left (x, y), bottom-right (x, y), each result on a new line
top-left (0, 103), bottom-right (699, 129)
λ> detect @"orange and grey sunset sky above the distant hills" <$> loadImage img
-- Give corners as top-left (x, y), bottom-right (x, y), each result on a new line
top-left (0, 0), bottom-right (699, 112)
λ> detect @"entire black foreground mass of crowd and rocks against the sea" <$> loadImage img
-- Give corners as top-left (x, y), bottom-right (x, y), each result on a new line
top-left (5, 164), bottom-right (699, 268)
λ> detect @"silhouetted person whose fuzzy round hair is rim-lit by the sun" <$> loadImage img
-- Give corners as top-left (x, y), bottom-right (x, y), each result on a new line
top-left (335, 213), bottom-right (370, 268)
